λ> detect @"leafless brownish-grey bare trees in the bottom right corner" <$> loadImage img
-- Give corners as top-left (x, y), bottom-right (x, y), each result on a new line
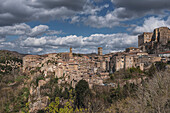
top-left (108, 70), bottom-right (170, 113)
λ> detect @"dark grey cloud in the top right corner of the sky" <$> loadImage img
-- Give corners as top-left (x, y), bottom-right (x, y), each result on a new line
top-left (111, 0), bottom-right (170, 18)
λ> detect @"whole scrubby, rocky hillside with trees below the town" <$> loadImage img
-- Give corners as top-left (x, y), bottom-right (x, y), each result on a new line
top-left (0, 50), bottom-right (170, 113)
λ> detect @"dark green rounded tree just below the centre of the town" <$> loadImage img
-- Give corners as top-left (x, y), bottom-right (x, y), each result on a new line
top-left (75, 80), bottom-right (90, 108)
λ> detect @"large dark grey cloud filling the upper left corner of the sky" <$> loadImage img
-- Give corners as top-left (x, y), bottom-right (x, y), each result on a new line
top-left (0, 0), bottom-right (88, 26)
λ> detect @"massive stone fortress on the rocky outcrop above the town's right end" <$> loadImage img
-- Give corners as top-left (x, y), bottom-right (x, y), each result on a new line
top-left (138, 27), bottom-right (170, 54)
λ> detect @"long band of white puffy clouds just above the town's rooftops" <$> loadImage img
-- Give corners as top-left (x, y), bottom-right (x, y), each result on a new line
top-left (0, 23), bottom-right (137, 54)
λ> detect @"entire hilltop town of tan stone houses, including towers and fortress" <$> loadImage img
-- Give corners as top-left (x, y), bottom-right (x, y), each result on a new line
top-left (23, 27), bottom-right (170, 88)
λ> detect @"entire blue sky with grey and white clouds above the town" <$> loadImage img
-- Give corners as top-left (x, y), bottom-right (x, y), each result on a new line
top-left (0, 0), bottom-right (170, 54)
